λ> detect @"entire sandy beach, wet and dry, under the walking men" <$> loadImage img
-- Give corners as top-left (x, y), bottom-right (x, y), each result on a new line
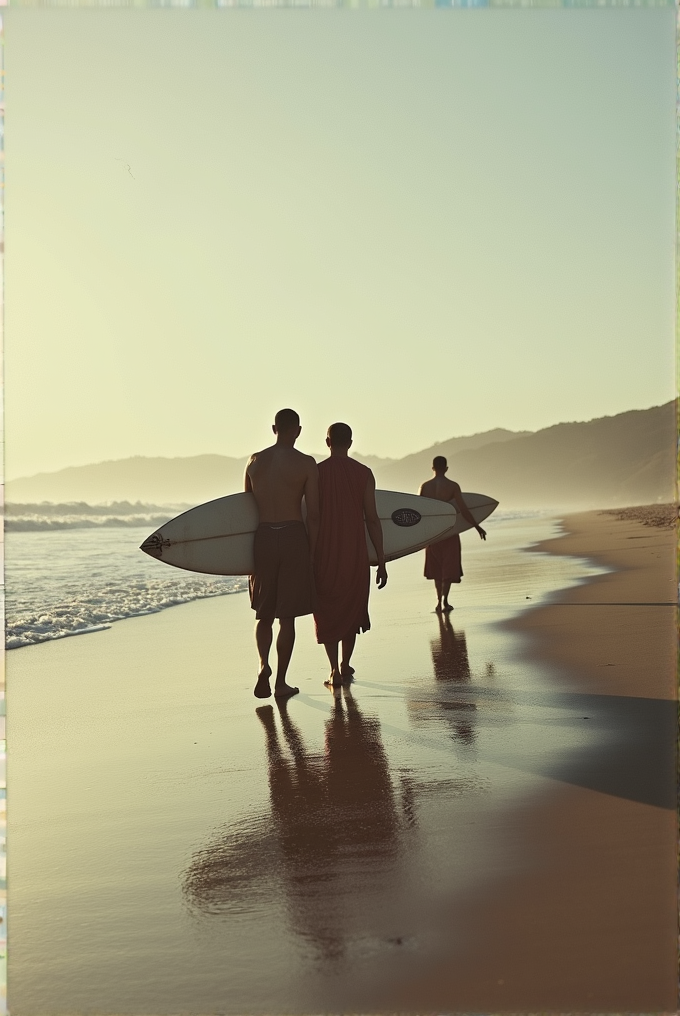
top-left (8, 512), bottom-right (677, 1016)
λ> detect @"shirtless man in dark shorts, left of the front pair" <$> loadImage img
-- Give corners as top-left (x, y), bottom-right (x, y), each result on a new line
top-left (245, 409), bottom-right (319, 698)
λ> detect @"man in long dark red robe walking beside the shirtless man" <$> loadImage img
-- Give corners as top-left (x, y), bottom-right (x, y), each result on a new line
top-left (314, 424), bottom-right (387, 687)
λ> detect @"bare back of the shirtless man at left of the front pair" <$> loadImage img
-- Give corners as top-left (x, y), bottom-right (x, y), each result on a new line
top-left (245, 444), bottom-right (318, 523)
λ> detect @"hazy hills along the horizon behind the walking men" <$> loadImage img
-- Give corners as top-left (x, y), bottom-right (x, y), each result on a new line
top-left (6, 402), bottom-right (676, 508)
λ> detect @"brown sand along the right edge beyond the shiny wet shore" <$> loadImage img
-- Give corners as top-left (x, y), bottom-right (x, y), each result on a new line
top-left (384, 505), bottom-right (677, 1013)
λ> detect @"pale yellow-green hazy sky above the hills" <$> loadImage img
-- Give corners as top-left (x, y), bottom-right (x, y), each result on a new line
top-left (3, 7), bottom-right (675, 479)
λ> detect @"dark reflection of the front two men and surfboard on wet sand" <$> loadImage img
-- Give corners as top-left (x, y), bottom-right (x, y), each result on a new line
top-left (183, 688), bottom-right (406, 961)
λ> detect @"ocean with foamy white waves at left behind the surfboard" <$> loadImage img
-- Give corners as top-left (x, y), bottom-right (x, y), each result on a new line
top-left (5, 503), bottom-right (247, 649)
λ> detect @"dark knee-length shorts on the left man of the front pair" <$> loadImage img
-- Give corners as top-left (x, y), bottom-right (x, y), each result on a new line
top-left (248, 521), bottom-right (314, 621)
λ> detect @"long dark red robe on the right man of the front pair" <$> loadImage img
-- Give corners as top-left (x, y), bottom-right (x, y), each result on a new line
top-left (314, 455), bottom-right (371, 642)
